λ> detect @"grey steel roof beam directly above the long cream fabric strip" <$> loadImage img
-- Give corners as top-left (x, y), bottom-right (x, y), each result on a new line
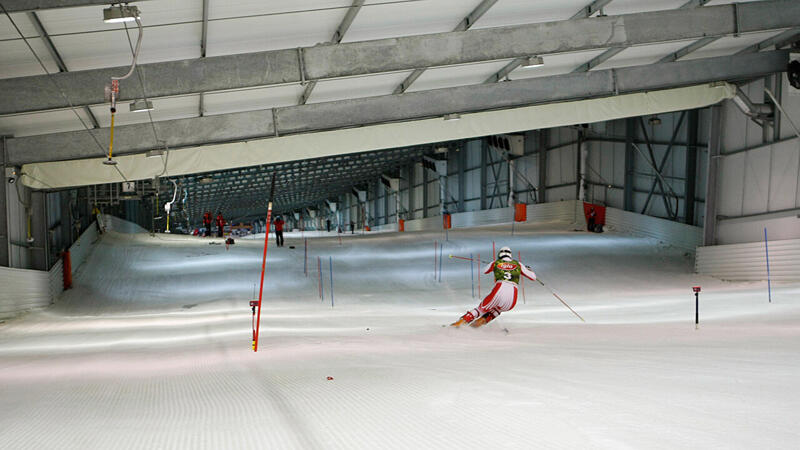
top-left (7, 50), bottom-right (789, 164)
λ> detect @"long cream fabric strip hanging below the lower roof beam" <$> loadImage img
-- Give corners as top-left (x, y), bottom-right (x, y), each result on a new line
top-left (22, 82), bottom-right (736, 189)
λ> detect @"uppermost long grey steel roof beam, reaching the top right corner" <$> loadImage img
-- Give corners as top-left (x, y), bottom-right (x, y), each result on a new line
top-left (0, 0), bottom-right (800, 114)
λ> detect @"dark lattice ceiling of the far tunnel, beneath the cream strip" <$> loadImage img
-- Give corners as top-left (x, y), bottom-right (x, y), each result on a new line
top-left (175, 145), bottom-right (434, 220)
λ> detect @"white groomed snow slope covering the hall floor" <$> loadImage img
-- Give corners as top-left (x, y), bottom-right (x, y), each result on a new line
top-left (0, 224), bottom-right (800, 449)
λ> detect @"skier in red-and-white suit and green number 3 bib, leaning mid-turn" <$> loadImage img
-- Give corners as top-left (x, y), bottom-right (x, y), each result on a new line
top-left (450, 247), bottom-right (536, 328)
